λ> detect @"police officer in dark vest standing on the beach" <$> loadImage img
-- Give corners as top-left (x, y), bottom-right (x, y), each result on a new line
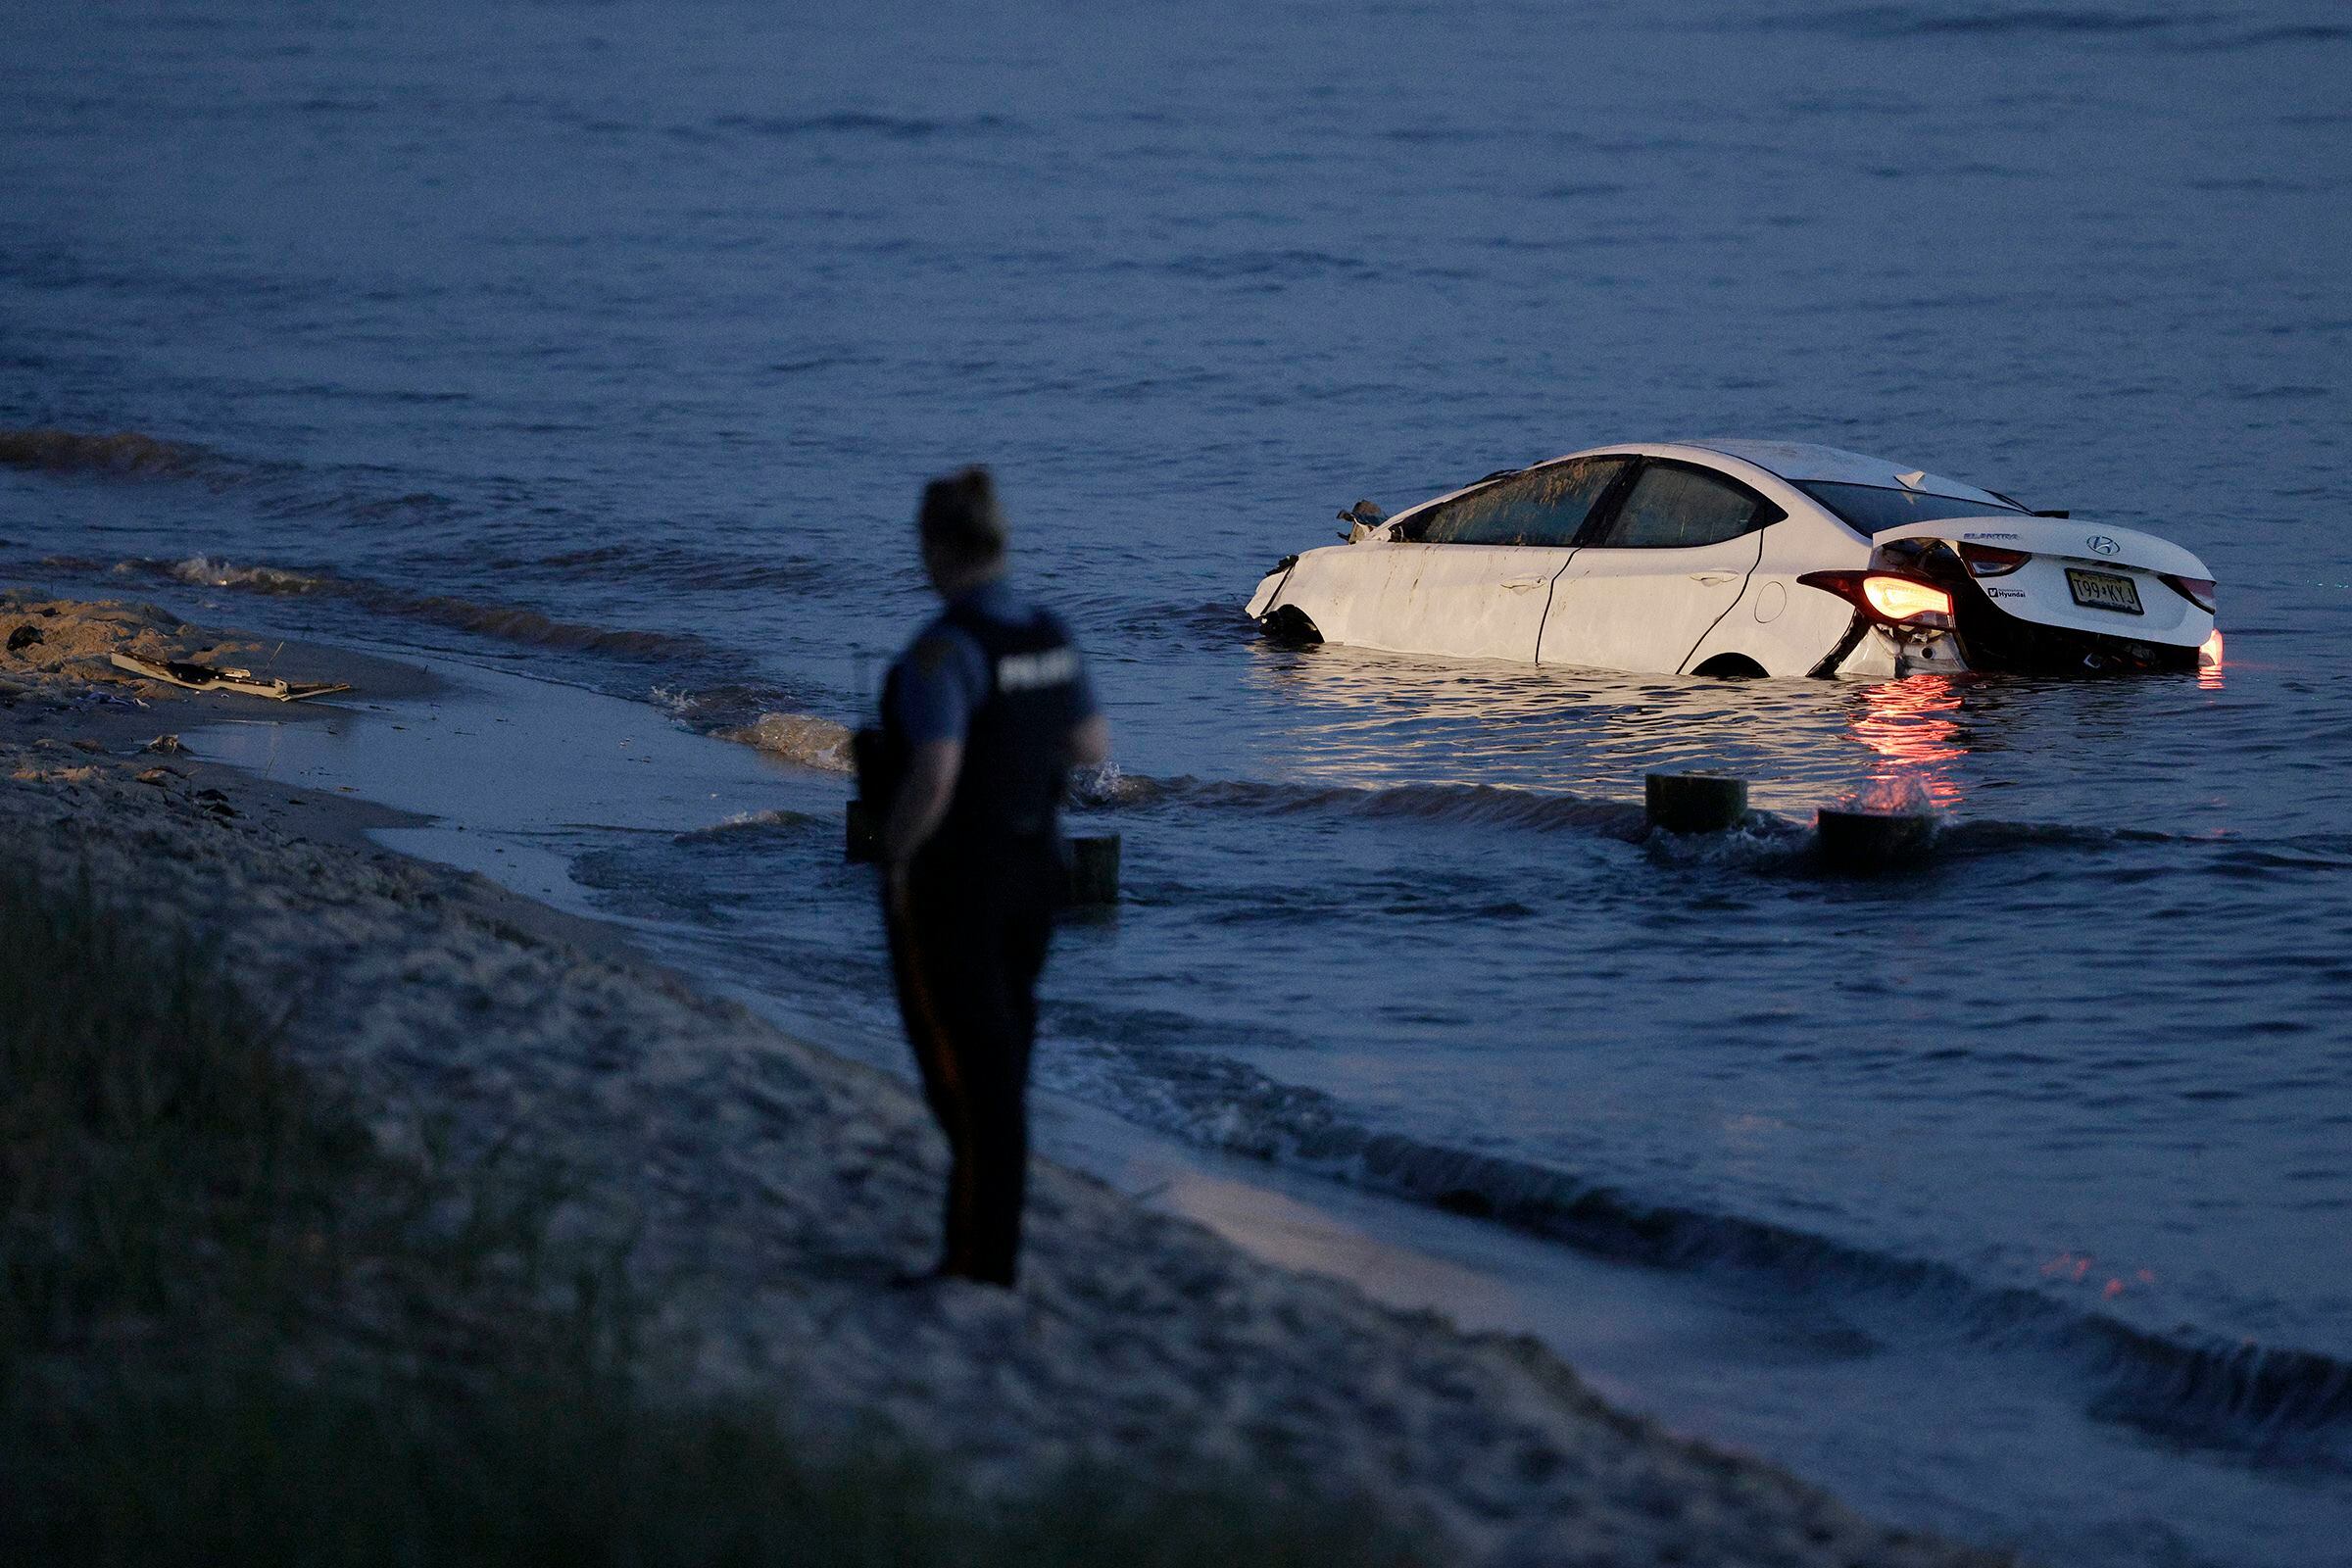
top-left (863, 467), bottom-right (1110, 1286)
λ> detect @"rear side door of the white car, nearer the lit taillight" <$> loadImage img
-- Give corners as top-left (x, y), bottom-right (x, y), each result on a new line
top-left (1536, 459), bottom-right (1783, 672)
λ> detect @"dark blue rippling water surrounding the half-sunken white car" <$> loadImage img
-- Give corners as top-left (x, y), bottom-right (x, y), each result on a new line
top-left (0, 0), bottom-right (2352, 1563)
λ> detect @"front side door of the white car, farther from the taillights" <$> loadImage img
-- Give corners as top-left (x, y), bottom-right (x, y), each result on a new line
top-left (1359, 459), bottom-right (1628, 662)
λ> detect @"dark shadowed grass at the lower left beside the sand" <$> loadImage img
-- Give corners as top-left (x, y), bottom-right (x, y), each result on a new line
top-left (0, 865), bottom-right (1411, 1568)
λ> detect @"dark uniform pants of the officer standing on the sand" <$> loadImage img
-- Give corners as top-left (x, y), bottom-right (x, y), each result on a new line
top-left (887, 839), bottom-right (1060, 1286)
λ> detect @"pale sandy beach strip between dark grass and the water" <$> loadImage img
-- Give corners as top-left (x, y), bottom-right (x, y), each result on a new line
top-left (0, 592), bottom-right (2006, 1566)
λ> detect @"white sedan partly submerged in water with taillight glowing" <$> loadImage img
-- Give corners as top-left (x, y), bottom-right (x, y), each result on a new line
top-left (1249, 442), bottom-right (2221, 677)
